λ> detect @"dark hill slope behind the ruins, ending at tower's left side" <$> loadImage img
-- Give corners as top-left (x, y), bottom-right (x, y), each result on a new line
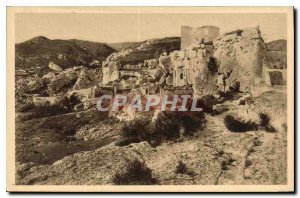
top-left (108, 37), bottom-right (180, 66)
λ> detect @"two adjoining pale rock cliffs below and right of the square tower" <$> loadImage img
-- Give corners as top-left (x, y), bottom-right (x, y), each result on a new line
top-left (165, 27), bottom-right (266, 96)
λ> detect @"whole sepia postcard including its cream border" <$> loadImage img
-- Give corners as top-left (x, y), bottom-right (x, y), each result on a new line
top-left (7, 7), bottom-right (294, 192)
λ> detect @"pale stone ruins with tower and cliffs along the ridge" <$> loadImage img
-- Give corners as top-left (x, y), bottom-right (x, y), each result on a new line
top-left (102, 26), bottom-right (286, 96)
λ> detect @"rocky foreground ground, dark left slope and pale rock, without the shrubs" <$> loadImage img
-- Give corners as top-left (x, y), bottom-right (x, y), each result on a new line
top-left (16, 87), bottom-right (287, 185)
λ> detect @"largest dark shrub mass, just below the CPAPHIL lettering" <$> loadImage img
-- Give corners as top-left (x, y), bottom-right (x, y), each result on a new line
top-left (118, 112), bottom-right (205, 145)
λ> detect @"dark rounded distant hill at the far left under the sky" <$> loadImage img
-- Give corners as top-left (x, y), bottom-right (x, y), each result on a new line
top-left (15, 36), bottom-right (115, 73)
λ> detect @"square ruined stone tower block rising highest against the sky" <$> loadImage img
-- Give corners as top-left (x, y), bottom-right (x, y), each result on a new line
top-left (181, 26), bottom-right (220, 50)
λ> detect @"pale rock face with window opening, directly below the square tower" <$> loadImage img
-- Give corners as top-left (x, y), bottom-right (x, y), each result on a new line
top-left (169, 44), bottom-right (217, 95)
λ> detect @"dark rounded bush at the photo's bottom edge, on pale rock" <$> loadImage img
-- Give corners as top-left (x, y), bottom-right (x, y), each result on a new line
top-left (112, 159), bottom-right (157, 185)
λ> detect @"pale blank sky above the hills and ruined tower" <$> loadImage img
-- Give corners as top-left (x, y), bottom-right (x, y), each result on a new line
top-left (15, 13), bottom-right (287, 43)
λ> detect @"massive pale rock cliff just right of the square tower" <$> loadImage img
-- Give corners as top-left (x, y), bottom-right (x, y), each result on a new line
top-left (213, 27), bottom-right (266, 91)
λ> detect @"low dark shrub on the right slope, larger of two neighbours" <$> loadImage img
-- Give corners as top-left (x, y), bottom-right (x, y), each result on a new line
top-left (224, 115), bottom-right (257, 132)
